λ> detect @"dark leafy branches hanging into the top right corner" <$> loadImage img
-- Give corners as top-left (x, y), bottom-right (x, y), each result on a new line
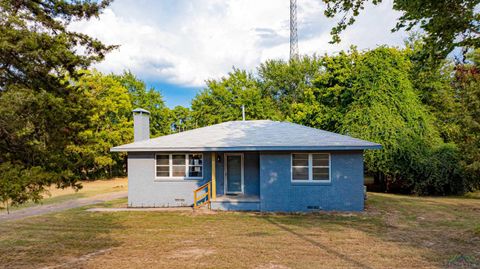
top-left (323, 0), bottom-right (480, 61)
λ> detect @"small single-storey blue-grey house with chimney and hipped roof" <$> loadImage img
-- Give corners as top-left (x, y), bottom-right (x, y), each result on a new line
top-left (111, 109), bottom-right (381, 212)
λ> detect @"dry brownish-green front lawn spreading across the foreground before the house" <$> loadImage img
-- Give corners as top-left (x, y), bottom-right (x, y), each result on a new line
top-left (0, 193), bottom-right (480, 268)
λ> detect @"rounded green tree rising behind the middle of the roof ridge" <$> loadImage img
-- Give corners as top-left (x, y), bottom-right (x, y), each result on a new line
top-left (192, 69), bottom-right (280, 126)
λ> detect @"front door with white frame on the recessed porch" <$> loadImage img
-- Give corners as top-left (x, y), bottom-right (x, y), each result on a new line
top-left (224, 153), bottom-right (243, 194)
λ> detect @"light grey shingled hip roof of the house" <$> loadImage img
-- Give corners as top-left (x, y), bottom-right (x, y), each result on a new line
top-left (111, 120), bottom-right (381, 151)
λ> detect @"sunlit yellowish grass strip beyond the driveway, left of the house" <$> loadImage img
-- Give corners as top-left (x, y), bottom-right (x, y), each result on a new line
top-left (0, 178), bottom-right (128, 212)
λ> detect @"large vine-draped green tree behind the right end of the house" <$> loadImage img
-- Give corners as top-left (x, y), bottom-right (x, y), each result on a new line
top-left (259, 47), bottom-right (468, 194)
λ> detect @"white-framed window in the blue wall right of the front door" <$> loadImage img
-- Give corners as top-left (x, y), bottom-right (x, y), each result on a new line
top-left (292, 153), bottom-right (330, 182)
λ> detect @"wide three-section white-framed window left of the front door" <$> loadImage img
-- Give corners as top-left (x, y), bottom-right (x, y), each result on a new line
top-left (155, 153), bottom-right (203, 178)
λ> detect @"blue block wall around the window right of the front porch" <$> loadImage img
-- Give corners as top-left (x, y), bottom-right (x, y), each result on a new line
top-left (260, 151), bottom-right (364, 212)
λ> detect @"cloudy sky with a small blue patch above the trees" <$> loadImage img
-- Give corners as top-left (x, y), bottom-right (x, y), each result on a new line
top-left (70, 0), bottom-right (407, 107)
